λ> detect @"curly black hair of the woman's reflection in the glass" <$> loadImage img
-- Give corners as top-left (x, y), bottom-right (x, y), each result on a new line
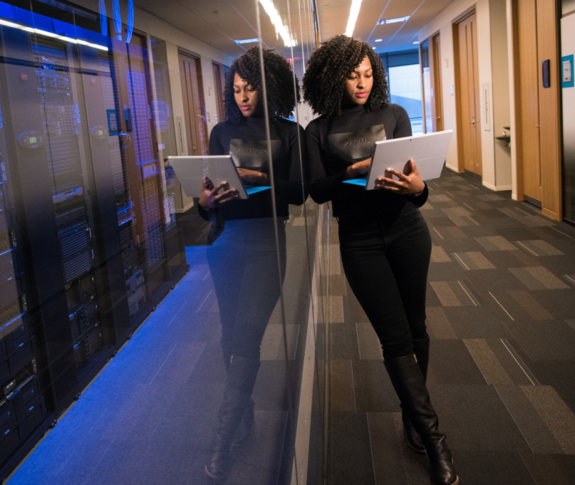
top-left (224, 47), bottom-right (300, 123)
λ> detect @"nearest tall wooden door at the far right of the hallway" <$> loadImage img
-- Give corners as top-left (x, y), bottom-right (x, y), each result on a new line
top-left (516, 0), bottom-right (542, 201)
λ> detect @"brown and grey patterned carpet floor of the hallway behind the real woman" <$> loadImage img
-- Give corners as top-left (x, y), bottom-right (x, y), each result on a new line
top-left (329, 171), bottom-right (575, 485)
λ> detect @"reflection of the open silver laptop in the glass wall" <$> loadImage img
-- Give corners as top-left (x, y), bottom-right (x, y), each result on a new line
top-left (168, 155), bottom-right (271, 199)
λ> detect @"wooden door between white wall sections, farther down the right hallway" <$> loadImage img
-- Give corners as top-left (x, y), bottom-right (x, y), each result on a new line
top-left (455, 12), bottom-right (482, 175)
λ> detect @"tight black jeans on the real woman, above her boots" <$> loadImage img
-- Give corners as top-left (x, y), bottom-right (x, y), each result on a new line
top-left (339, 204), bottom-right (431, 359)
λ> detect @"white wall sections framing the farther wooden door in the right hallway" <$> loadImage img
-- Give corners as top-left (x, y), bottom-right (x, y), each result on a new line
top-left (419, 0), bottom-right (511, 190)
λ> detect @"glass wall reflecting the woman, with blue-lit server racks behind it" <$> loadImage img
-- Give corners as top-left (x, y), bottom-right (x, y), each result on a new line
top-left (0, 0), bottom-right (326, 485)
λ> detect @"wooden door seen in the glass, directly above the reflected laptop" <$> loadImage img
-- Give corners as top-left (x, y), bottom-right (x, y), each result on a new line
top-left (179, 52), bottom-right (208, 155)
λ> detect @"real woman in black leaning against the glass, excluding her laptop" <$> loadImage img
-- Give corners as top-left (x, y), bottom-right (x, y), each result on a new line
top-left (303, 35), bottom-right (459, 485)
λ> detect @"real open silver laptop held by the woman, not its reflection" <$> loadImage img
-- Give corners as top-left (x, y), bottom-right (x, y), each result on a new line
top-left (344, 130), bottom-right (453, 190)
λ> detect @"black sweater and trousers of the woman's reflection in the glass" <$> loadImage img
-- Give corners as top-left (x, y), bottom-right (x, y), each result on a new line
top-left (202, 116), bottom-right (304, 360)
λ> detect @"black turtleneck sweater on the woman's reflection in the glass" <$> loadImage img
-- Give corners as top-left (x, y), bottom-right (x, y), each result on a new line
top-left (198, 116), bottom-right (307, 220)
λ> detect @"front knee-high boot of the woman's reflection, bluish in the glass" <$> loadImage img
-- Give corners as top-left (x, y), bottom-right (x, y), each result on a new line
top-left (206, 356), bottom-right (260, 480)
